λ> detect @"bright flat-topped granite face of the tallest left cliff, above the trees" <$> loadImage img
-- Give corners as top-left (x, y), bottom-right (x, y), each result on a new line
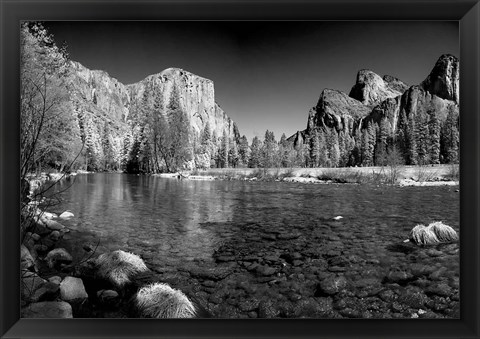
top-left (127, 68), bottom-right (238, 138)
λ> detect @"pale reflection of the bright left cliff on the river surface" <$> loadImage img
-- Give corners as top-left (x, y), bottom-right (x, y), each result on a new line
top-left (52, 174), bottom-right (233, 266)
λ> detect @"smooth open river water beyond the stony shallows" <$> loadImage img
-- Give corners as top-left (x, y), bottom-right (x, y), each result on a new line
top-left (50, 174), bottom-right (459, 265)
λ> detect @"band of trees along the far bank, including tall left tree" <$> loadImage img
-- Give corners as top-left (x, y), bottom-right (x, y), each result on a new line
top-left (21, 23), bottom-right (459, 175)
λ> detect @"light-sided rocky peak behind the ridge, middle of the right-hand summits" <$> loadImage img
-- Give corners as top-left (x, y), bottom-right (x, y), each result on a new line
top-left (350, 69), bottom-right (407, 106)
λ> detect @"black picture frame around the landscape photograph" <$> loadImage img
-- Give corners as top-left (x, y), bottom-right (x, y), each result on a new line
top-left (0, 0), bottom-right (480, 338)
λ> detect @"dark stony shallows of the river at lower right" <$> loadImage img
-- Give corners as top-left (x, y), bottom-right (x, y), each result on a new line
top-left (134, 220), bottom-right (459, 318)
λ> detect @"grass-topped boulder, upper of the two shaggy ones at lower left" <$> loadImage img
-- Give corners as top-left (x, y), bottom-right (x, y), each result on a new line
top-left (95, 250), bottom-right (148, 288)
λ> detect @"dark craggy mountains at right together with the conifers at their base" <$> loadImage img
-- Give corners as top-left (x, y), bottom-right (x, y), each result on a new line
top-left (289, 55), bottom-right (459, 166)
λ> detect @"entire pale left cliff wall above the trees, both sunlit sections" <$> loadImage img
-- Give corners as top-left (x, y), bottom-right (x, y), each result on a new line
top-left (71, 62), bottom-right (239, 140)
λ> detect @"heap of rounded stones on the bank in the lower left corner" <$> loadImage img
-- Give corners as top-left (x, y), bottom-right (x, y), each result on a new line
top-left (21, 204), bottom-right (88, 318)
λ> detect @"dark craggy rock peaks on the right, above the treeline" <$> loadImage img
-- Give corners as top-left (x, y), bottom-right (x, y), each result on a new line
top-left (288, 55), bottom-right (459, 167)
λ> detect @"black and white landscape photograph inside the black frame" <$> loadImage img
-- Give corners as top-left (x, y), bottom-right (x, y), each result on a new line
top-left (19, 20), bottom-right (466, 321)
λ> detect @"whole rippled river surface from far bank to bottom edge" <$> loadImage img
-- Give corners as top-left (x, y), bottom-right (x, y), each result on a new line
top-left (50, 174), bottom-right (460, 317)
